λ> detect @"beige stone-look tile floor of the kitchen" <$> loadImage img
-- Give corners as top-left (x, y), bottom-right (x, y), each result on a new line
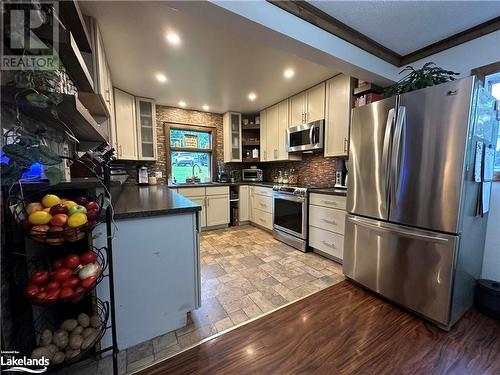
top-left (56, 225), bottom-right (344, 375)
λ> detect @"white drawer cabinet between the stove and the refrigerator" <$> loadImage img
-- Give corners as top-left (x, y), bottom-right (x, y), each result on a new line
top-left (309, 193), bottom-right (346, 262)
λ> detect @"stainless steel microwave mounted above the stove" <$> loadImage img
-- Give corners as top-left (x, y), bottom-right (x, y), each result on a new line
top-left (286, 120), bottom-right (325, 152)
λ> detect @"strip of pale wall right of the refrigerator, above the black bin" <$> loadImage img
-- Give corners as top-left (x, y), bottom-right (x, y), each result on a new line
top-left (482, 182), bottom-right (500, 281)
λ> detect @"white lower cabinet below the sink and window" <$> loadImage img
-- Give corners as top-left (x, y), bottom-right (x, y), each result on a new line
top-left (177, 186), bottom-right (230, 228)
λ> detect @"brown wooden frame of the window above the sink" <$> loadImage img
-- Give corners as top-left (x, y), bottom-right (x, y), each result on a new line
top-left (164, 122), bottom-right (217, 181)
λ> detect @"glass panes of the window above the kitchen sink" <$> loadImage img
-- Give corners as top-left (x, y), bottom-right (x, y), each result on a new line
top-left (168, 124), bottom-right (212, 183)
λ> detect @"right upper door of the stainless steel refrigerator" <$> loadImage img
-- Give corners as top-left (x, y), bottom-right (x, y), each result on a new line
top-left (390, 79), bottom-right (472, 233)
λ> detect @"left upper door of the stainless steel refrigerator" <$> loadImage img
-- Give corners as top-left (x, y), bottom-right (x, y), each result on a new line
top-left (347, 98), bottom-right (395, 220)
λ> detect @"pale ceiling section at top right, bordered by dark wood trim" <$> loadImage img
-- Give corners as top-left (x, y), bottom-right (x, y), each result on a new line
top-left (308, 0), bottom-right (500, 55)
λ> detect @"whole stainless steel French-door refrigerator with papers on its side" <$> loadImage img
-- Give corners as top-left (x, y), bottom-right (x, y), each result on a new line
top-left (343, 77), bottom-right (498, 329)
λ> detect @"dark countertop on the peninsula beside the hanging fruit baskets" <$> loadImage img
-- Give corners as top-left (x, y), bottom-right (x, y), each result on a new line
top-left (113, 185), bottom-right (201, 220)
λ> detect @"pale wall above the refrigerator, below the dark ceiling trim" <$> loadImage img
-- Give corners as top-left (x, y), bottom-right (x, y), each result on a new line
top-left (410, 30), bottom-right (500, 77)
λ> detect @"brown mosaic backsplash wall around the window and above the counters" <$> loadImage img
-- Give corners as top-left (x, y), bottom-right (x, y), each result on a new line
top-left (114, 105), bottom-right (342, 186)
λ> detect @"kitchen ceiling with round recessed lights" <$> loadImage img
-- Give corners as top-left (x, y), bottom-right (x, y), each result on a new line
top-left (80, 1), bottom-right (339, 113)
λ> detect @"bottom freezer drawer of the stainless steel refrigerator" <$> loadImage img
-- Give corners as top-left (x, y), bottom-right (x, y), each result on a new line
top-left (343, 215), bottom-right (459, 325)
